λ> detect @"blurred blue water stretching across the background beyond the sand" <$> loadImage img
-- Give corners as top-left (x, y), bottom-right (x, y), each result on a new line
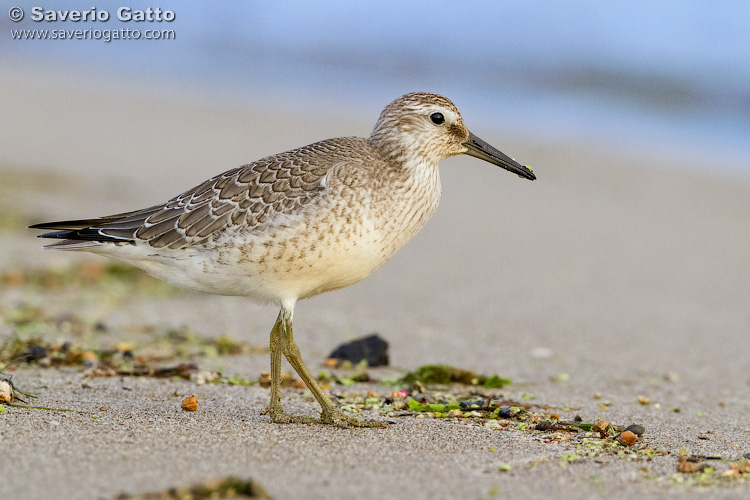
top-left (0, 0), bottom-right (750, 172)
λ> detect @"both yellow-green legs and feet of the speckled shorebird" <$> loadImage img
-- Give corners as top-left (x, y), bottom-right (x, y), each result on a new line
top-left (266, 307), bottom-right (388, 427)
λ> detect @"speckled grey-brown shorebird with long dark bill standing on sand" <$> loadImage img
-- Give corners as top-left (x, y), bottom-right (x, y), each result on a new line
top-left (30, 93), bottom-right (536, 427)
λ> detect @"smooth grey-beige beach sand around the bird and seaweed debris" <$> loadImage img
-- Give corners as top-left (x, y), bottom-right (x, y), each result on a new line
top-left (0, 67), bottom-right (750, 499)
